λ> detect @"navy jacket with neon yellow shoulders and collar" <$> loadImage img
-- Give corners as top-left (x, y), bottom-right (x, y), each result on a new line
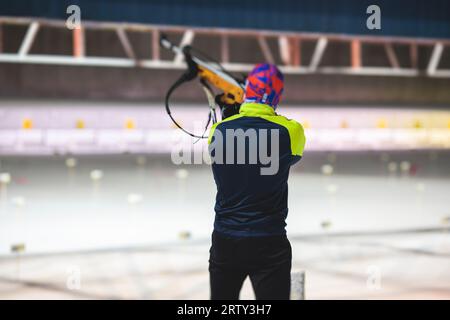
top-left (208, 103), bottom-right (305, 237)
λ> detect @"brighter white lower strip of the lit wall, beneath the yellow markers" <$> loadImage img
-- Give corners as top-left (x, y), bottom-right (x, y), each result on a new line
top-left (0, 129), bottom-right (450, 155)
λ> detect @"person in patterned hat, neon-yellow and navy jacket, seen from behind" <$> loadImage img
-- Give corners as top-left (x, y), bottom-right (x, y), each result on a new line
top-left (209, 64), bottom-right (305, 299)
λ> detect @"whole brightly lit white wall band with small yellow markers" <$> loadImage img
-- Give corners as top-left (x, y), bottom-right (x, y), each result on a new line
top-left (0, 101), bottom-right (450, 155)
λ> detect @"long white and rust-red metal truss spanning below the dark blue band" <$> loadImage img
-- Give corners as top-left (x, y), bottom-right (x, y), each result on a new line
top-left (0, 17), bottom-right (450, 78)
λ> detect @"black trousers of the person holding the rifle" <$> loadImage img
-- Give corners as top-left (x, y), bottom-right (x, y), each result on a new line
top-left (209, 232), bottom-right (292, 300)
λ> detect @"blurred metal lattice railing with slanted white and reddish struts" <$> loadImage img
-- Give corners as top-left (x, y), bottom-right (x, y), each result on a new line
top-left (0, 16), bottom-right (450, 78)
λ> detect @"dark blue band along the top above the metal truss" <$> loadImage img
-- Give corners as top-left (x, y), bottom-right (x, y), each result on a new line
top-left (0, 0), bottom-right (450, 38)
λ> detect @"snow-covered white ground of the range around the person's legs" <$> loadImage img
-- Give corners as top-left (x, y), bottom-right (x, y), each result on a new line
top-left (0, 151), bottom-right (450, 299)
